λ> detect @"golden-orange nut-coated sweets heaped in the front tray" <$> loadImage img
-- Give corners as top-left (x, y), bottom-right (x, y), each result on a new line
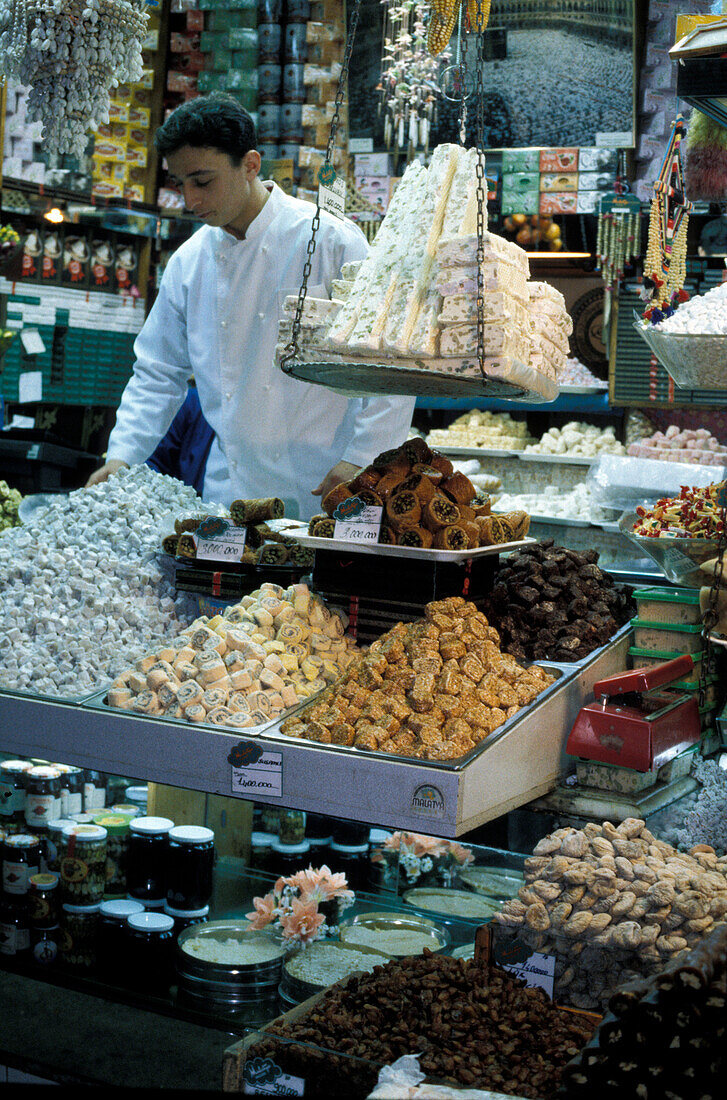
top-left (282, 596), bottom-right (553, 760)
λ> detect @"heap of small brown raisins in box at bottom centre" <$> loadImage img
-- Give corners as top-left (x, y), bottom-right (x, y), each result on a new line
top-left (247, 949), bottom-right (596, 1098)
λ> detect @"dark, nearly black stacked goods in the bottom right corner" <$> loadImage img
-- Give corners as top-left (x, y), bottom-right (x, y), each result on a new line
top-left (563, 925), bottom-right (727, 1100)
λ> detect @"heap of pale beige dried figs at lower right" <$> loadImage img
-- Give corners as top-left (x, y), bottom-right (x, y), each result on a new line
top-left (494, 817), bottom-right (727, 1009)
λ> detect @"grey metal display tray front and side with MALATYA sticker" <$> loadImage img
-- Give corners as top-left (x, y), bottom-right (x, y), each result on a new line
top-left (0, 628), bottom-right (631, 837)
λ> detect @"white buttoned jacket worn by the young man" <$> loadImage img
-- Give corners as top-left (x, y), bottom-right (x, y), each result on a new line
top-left (107, 184), bottom-right (414, 518)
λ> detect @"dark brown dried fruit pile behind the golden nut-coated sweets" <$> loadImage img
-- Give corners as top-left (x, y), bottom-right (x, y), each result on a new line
top-left (485, 539), bottom-right (635, 661)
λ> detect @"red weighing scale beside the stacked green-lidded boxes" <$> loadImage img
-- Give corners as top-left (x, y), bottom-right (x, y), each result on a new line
top-left (565, 653), bottom-right (702, 771)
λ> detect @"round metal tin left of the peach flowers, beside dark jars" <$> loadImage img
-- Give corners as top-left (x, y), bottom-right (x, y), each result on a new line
top-left (176, 921), bottom-right (286, 1005)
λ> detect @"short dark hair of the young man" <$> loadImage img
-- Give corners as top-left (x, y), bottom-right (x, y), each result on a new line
top-left (154, 91), bottom-right (257, 167)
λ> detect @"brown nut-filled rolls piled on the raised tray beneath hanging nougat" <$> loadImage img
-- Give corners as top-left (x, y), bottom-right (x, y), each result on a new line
top-left (308, 437), bottom-right (530, 550)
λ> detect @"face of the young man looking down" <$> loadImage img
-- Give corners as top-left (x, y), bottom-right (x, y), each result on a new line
top-left (167, 145), bottom-right (260, 228)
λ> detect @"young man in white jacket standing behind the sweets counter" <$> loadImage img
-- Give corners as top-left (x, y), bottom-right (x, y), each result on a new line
top-left (88, 95), bottom-right (414, 519)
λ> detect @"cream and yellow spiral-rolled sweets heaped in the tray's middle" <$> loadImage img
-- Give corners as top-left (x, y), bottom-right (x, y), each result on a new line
top-left (109, 583), bottom-right (356, 729)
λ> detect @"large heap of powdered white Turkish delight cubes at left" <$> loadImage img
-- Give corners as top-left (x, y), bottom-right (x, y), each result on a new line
top-left (0, 465), bottom-right (215, 697)
